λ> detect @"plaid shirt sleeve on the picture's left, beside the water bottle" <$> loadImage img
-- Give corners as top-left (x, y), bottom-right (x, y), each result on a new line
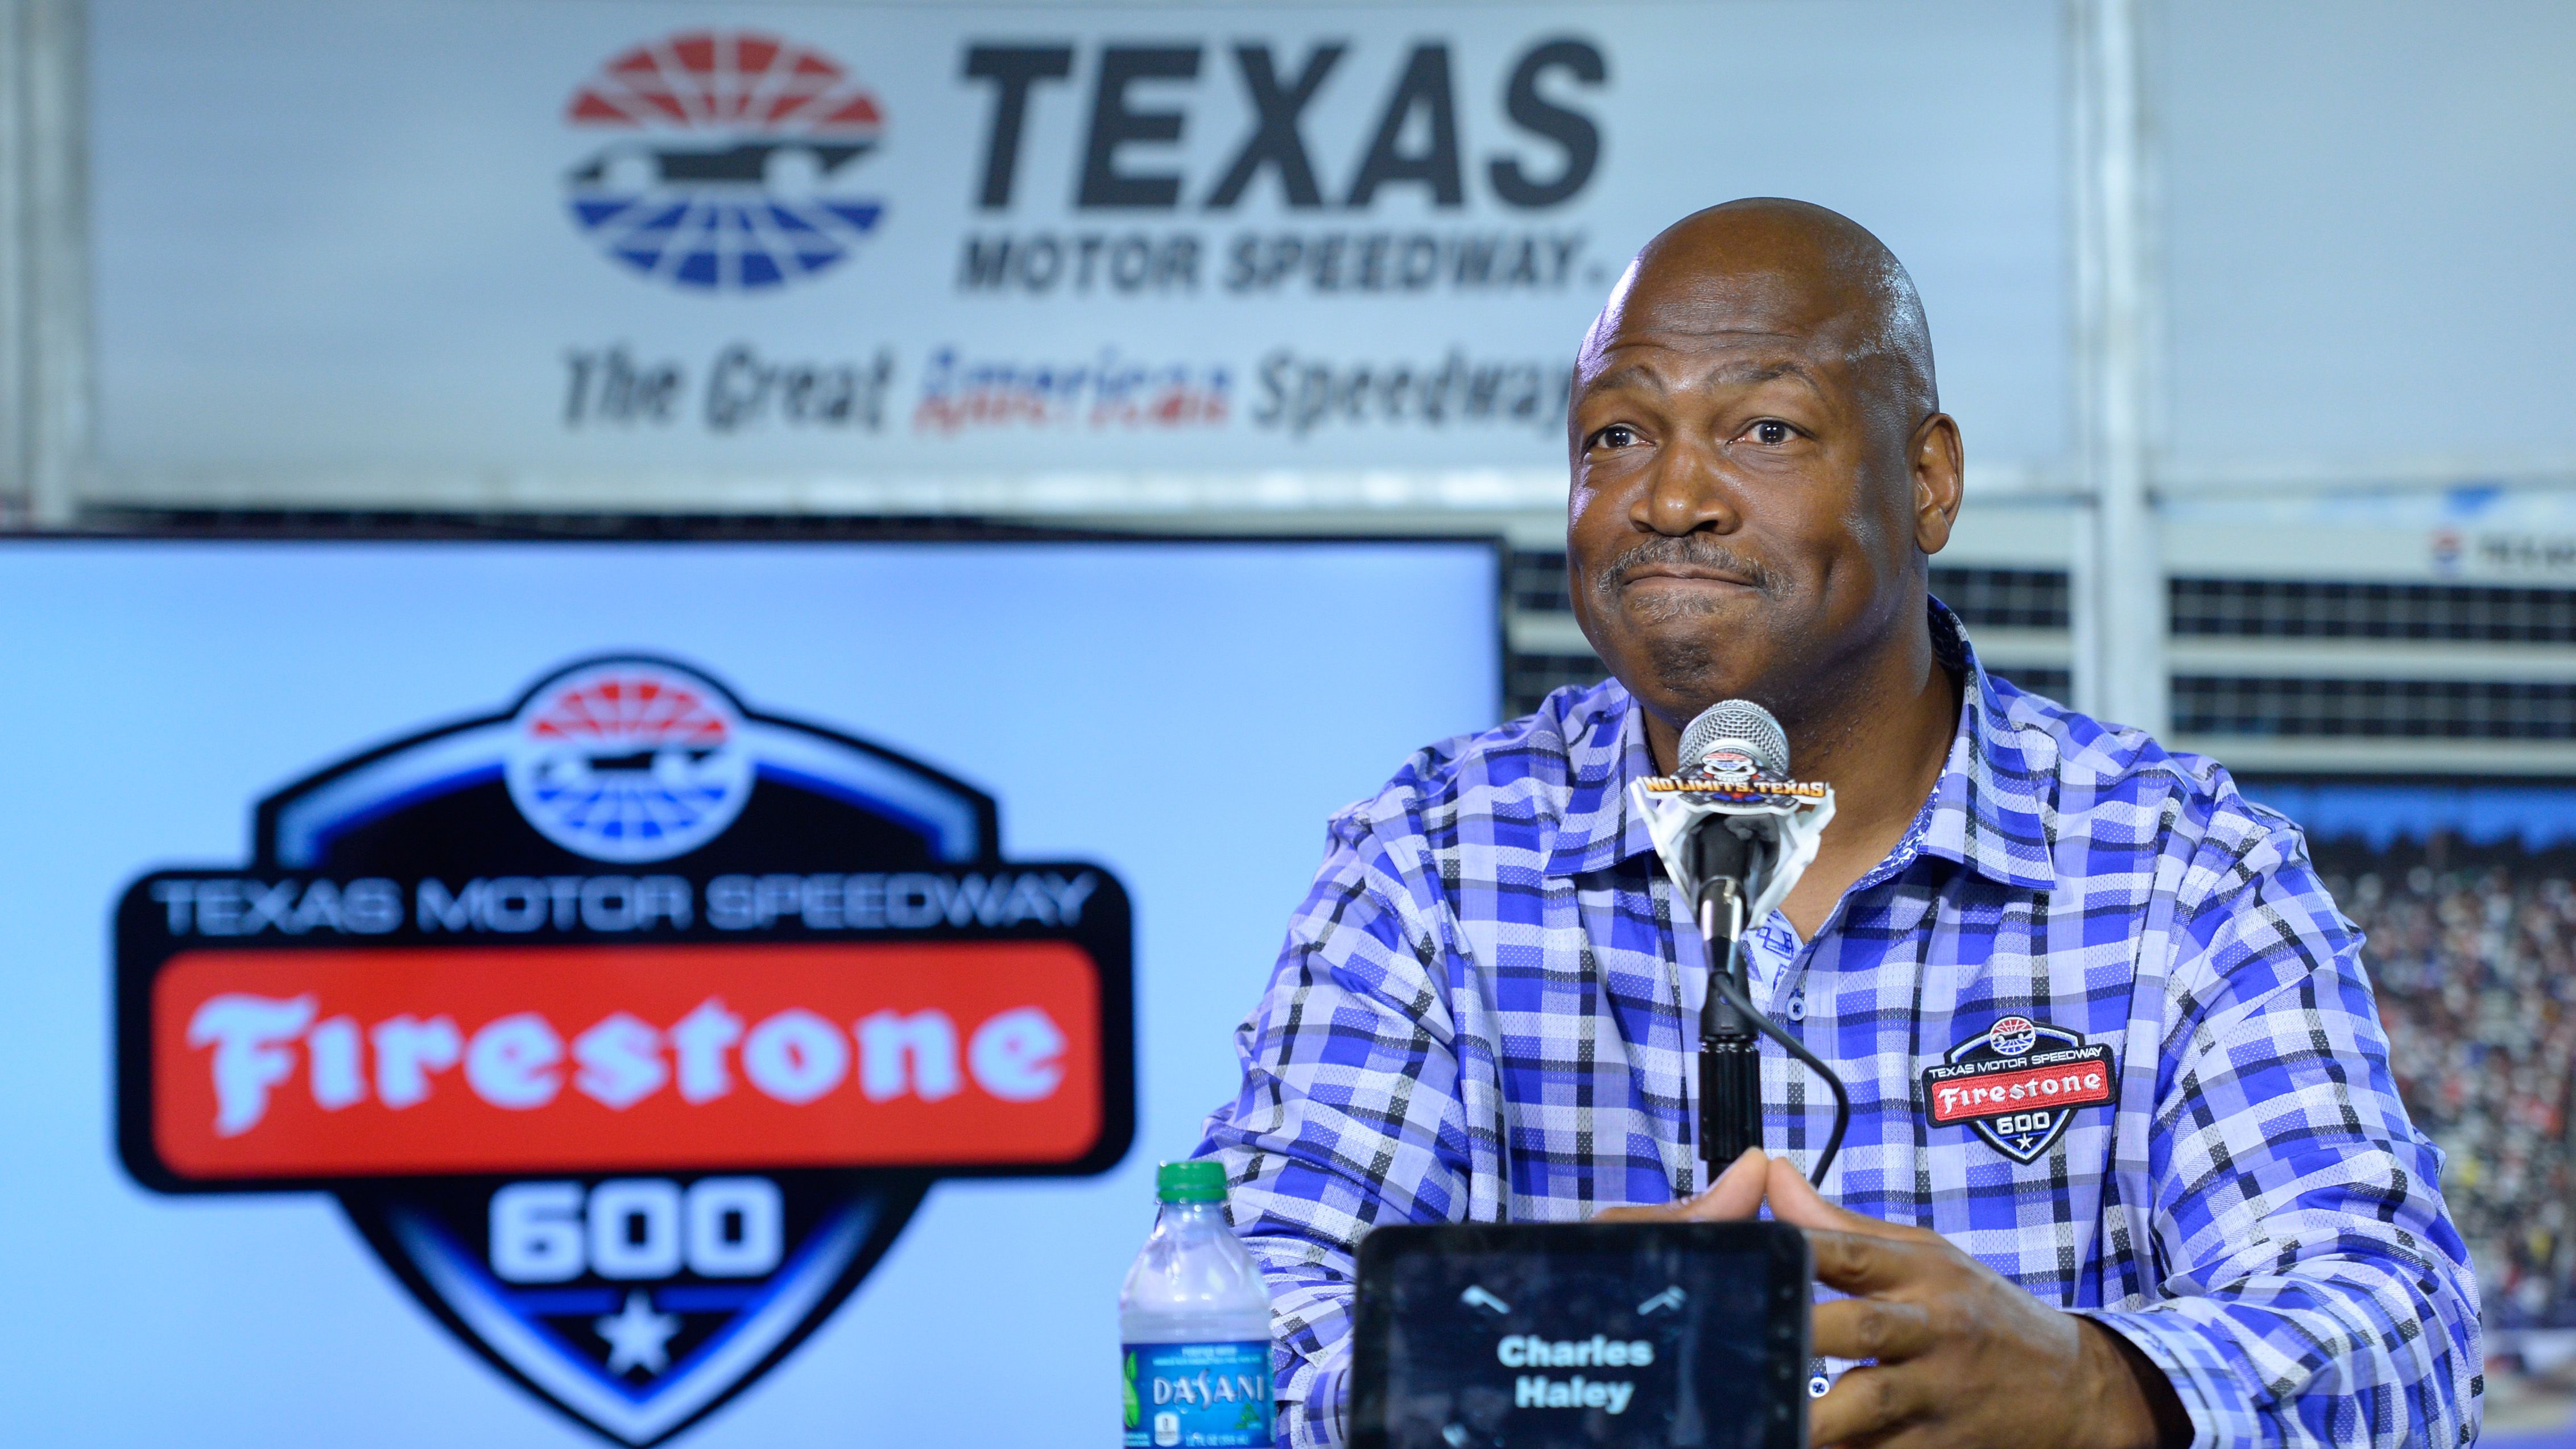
top-left (1201, 813), bottom-right (1499, 1446)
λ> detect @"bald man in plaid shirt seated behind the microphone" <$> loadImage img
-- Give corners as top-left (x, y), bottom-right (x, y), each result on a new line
top-left (1203, 201), bottom-right (2483, 1449)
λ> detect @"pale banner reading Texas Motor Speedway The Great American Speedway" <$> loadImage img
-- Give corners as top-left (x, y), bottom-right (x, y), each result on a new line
top-left (90, 0), bottom-right (2066, 510)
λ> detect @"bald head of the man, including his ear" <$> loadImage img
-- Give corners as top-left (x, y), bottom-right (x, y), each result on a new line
top-left (1566, 198), bottom-right (1961, 736)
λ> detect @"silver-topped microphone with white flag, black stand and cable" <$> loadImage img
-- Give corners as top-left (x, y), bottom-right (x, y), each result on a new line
top-left (1631, 700), bottom-right (1852, 1184)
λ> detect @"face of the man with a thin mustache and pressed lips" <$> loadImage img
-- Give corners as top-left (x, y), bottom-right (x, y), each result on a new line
top-left (1566, 263), bottom-right (1919, 726)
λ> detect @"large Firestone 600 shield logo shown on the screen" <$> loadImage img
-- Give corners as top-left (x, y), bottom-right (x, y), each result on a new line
top-left (116, 656), bottom-right (1134, 1444)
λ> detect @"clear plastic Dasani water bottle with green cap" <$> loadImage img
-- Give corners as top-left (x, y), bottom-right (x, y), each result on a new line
top-left (1118, 1161), bottom-right (1270, 1449)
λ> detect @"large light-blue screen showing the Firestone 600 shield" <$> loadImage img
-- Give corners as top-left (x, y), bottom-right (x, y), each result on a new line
top-left (0, 540), bottom-right (1499, 1446)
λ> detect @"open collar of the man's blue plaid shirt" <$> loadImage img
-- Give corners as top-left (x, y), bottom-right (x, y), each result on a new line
top-left (1545, 600), bottom-right (2058, 891)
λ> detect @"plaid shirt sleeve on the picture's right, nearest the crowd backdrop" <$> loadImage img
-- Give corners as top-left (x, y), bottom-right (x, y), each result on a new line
top-left (2092, 826), bottom-right (2483, 1449)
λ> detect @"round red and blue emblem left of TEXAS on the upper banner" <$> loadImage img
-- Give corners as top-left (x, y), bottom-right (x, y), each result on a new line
top-left (564, 31), bottom-right (886, 291)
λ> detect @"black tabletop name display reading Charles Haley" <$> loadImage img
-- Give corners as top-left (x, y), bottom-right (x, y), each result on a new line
top-left (1350, 1223), bottom-right (1813, 1449)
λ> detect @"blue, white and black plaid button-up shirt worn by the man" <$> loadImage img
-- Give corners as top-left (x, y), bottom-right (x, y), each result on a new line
top-left (1201, 605), bottom-right (2483, 1449)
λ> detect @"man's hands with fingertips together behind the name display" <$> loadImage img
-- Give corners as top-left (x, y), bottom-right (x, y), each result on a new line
top-left (1600, 1148), bottom-right (2190, 1449)
